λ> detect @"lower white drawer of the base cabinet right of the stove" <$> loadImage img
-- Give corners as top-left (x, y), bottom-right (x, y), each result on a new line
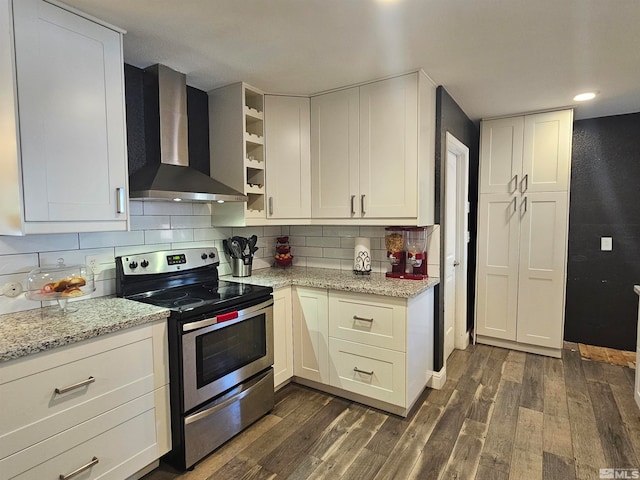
top-left (329, 338), bottom-right (406, 407)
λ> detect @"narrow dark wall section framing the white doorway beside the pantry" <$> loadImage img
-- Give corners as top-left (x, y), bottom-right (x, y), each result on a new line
top-left (434, 86), bottom-right (479, 371)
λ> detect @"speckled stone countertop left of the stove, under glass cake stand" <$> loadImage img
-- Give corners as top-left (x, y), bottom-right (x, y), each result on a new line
top-left (0, 297), bottom-right (169, 362)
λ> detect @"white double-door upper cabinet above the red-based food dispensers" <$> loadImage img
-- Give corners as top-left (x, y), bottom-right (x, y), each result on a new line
top-left (311, 72), bottom-right (435, 225)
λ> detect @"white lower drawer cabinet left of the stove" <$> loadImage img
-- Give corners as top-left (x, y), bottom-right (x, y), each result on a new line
top-left (0, 321), bottom-right (171, 480)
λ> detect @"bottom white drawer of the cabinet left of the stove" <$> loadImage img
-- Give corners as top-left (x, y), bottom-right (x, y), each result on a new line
top-left (0, 393), bottom-right (159, 480)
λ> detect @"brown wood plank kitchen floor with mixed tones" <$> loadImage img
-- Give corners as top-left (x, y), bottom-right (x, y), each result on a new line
top-left (144, 345), bottom-right (640, 480)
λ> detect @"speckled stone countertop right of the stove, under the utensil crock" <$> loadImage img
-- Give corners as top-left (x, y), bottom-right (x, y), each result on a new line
top-left (220, 267), bottom-right (440, 298)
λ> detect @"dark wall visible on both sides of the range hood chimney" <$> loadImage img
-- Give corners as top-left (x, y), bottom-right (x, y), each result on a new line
top-left (124, 63), bottom-right (209, 175)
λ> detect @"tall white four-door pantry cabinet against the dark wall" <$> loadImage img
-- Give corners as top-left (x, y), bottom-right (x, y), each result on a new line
top-left (475, 110), bottom-right (573, 357)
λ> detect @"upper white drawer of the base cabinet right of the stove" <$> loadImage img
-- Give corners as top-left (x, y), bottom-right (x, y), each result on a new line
top-left (329, 292), bottom-right (407, 352)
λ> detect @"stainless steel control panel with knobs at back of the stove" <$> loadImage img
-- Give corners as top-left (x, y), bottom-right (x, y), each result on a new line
top-left (116, 247), bottom-right (220, 275)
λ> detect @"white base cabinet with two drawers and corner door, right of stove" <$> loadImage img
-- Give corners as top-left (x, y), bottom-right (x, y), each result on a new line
top-left (293, 287), bottom-right (433, 415)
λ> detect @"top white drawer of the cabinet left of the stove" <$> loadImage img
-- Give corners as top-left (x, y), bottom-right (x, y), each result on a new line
top-left (0, 336), bottom-right (154, 458)
